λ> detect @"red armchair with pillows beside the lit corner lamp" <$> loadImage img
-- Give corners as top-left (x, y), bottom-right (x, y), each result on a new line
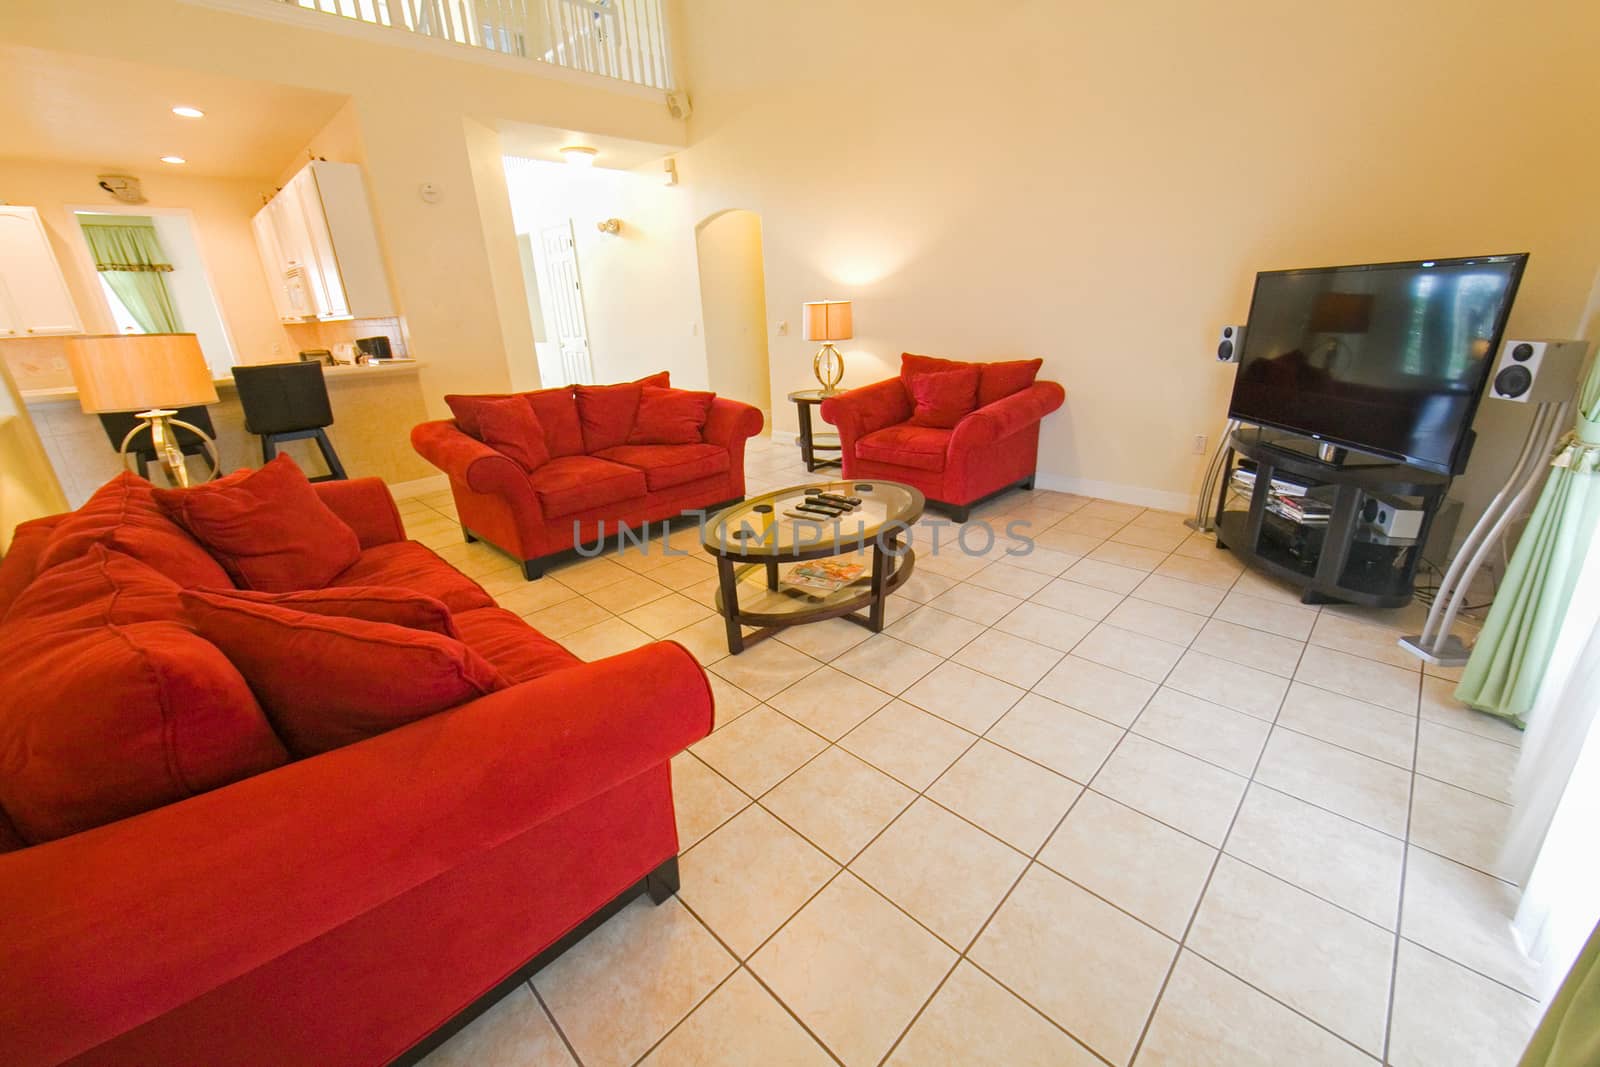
top-left (822, 352), bottom-right (1067, 522)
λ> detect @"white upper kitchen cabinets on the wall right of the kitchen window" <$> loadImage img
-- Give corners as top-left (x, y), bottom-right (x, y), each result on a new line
top-left (256, 160), bottom-right (395, 322)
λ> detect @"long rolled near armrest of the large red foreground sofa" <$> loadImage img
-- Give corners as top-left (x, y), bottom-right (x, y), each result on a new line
top-left (0, 641), bottom-right (712, 1064)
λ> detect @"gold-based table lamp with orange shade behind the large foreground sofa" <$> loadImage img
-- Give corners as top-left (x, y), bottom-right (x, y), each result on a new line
top-left (67, 333), bottom-right (218, 486)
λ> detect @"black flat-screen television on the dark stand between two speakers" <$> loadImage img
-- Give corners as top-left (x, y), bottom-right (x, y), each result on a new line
top-left (1229, 254), bottom-right (1528, 474)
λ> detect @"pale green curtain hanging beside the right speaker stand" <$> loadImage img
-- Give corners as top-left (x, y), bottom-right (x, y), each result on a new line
top-left (1456, 350), bottom-right (1600, 725)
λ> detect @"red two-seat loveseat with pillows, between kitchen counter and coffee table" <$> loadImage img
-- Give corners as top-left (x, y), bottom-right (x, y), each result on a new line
top-left (411, 373), bottom-right (762, 581)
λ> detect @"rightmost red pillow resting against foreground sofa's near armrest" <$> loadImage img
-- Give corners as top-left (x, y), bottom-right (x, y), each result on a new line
top-left (182, 590), bottom-right (507, 757)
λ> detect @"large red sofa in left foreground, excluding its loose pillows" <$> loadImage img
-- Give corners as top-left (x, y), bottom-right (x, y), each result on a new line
top-left (0, 475), bottom-right (712, 1067)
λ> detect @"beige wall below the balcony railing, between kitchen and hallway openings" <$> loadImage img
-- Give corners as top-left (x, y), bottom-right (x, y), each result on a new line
top-left (0, 0), bottom-right (683, 414)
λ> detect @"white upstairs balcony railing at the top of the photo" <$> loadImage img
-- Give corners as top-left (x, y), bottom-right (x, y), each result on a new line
top-left (278, 0), bottom-right (672, 91)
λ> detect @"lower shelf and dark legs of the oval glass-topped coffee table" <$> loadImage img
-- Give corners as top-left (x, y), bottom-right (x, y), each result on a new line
top-left (714, 544), bottom-right (917, 654)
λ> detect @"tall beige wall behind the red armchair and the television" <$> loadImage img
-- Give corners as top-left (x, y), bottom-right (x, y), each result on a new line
top-left (678, 0), bottom-right (1600, 506)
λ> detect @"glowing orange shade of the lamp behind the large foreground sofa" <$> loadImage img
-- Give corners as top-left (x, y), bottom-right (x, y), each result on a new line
top-left (67, 333), bottom-right (216, 414)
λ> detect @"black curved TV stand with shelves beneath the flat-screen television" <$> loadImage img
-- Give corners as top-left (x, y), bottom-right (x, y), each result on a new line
top-left (1216, 429), bottom-right (1450, 608)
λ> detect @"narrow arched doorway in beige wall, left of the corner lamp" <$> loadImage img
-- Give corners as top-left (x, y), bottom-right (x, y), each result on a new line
top-left (694, 208), bottom-right (771, 424)
